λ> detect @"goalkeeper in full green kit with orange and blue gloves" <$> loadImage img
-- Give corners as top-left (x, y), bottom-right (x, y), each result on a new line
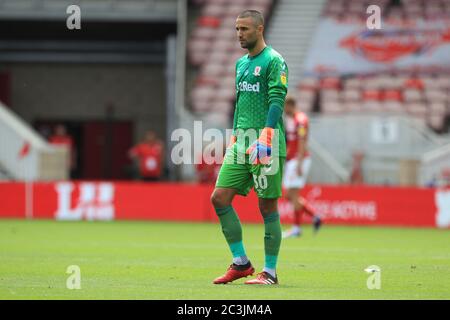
top-left (211, 10), bottom-right (288, 285)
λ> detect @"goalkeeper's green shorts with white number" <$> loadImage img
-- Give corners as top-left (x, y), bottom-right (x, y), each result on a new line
top-left (216, 143), bottom-right (285, 199)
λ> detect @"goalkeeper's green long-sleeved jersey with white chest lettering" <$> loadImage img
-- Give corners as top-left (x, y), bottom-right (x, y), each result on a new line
top-left (233, 46), bottom-right (288, 157)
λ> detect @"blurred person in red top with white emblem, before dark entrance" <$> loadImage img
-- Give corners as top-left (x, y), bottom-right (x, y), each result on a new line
top-left (128, 130), bottom-right (164, 181)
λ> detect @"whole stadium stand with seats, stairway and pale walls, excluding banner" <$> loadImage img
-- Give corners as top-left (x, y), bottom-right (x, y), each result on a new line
top-left (187, 0), bottom-right (450, 185)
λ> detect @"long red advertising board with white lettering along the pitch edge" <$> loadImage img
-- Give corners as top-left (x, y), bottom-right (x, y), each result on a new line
top-left (0, 181), bottom-right (450, 228)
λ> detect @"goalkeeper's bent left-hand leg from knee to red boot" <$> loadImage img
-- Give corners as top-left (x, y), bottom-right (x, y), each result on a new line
top-left (211, 188), bottom-right (255, 284)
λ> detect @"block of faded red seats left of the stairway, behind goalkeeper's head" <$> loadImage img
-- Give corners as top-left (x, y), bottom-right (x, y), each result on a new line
top-left (188, 0), bottom-right (272, 117)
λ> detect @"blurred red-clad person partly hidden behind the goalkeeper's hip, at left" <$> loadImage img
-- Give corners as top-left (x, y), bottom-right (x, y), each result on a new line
top-left (195, 143), bottom-right (225, 184)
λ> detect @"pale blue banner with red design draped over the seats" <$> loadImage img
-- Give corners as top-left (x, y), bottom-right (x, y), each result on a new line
top-left (305, 18), bottom-right (450, 74)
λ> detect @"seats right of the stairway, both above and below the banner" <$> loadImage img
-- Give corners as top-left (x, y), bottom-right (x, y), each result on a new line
top-left (284, 0), bottom-right (450, 132)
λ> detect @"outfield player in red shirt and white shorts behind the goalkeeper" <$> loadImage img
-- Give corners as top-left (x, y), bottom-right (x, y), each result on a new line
top-left (283, 97), bottom-right (322, 238)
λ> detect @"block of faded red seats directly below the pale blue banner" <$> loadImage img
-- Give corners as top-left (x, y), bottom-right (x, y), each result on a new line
top-left (295, 72), bottom-right (450, 131)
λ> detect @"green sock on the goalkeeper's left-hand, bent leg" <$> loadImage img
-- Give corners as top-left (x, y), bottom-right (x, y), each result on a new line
top-left (215, 206), bottom-right (247, 263)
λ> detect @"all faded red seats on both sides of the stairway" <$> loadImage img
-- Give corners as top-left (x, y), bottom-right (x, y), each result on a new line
top-left (188, 0), bottom-right (450, 132)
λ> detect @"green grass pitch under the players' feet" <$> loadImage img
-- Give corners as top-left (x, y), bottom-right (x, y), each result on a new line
top-left (0, 220), bottom-right (450, 300)
